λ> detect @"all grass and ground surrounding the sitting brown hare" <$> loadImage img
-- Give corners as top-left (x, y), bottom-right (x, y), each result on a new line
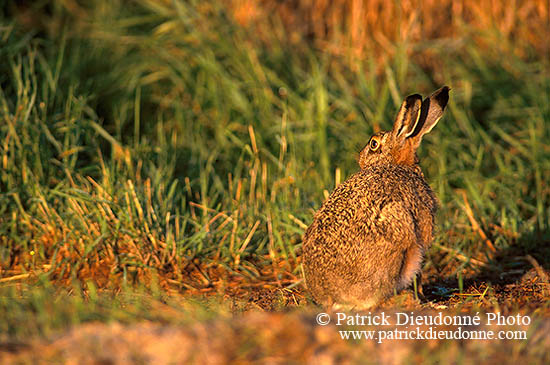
top-left (0, 0), bottom-right (550, 363)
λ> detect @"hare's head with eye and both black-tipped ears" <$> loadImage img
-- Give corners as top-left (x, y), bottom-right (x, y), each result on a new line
top-left (359, 86), bottom-right (450, 169)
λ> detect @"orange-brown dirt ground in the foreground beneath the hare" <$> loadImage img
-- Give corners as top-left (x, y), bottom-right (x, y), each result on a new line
top-left (0, 260), bottom-right (550, 364)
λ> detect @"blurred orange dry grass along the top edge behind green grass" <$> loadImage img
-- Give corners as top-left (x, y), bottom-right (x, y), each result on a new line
top-left (230, 0), bottom-right (550, 62)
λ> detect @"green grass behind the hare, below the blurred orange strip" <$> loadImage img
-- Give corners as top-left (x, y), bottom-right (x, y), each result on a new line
top-left (0, 0), bottom-right (550, 362)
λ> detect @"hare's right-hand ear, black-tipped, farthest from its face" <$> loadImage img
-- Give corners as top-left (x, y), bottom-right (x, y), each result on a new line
top-left (409, 86), bottom-right (450, 146)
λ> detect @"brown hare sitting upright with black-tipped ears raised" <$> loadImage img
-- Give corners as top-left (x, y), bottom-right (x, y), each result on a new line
top-left (303, 86), bottom-right (450, 309)
